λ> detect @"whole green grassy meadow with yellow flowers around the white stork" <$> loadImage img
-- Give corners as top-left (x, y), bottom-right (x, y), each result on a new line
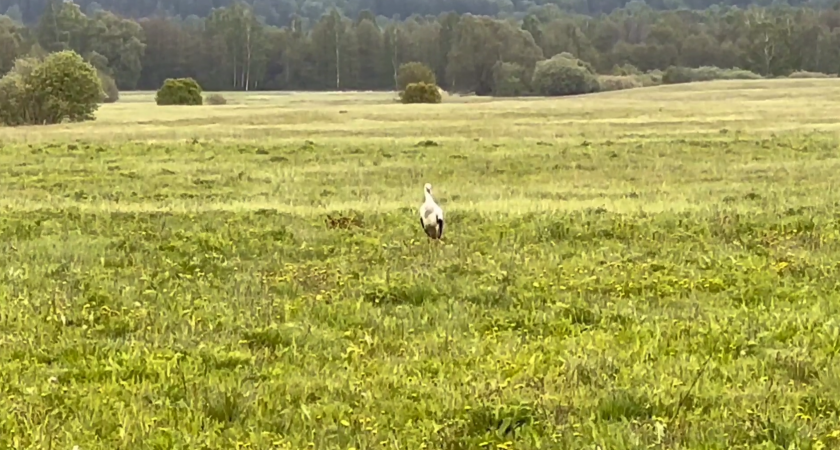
top-left (0, 79), bottom-right (840, 450)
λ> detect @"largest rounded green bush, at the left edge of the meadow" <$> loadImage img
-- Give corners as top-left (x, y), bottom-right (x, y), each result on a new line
top-left (0, 50), bottom-right (106, 126)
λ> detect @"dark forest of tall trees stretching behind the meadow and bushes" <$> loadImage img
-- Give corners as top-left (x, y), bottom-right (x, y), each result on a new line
top-left (0, 0), bottom-right (840, 94)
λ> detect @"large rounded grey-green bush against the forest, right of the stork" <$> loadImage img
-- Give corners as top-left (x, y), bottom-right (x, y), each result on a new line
top-left (531, 53), bottom-right (601, 97)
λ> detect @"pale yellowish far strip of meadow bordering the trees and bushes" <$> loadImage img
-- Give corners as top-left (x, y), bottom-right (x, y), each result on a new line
top-left (0, 79), bottom-right (840, 143)
